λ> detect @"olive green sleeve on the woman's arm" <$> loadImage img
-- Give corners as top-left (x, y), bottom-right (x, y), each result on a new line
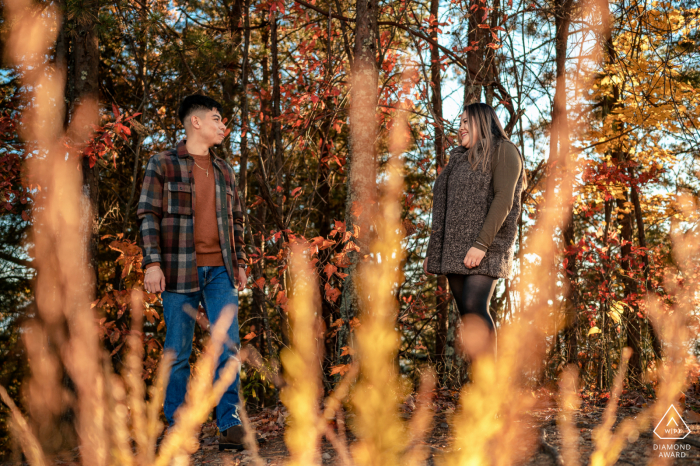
top-left (473, 142), bottom-right (522, 251)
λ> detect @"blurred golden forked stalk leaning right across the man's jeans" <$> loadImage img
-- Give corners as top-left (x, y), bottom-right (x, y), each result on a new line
top-left (154, 307), bottom-right (240, 466)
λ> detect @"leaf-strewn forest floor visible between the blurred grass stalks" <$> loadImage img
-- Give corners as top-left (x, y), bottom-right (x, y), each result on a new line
top-left (193, 390), bottom-right (700, 466)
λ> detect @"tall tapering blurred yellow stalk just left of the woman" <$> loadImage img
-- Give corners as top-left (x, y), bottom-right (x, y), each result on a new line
top-left (353, 151), bottom-right (406, 465)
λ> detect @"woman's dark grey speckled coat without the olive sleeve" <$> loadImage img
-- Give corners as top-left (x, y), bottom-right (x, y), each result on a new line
top-left (428, 141), bottom-right (525, 278)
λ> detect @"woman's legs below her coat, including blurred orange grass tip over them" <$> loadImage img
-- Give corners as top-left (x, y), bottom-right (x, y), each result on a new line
top-left (447, 274), bottom-right (498, 357)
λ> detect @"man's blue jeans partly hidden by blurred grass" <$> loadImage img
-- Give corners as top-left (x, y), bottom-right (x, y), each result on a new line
top-left (161, 266), bottom-right (241, 432)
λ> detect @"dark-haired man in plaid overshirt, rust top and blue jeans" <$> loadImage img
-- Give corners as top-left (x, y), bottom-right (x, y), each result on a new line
top-left (137, 95), bottom-right (246, 449)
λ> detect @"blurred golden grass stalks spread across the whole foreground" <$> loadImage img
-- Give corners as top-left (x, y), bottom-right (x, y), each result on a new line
top-left (0, 0), bottom-right (700, 466)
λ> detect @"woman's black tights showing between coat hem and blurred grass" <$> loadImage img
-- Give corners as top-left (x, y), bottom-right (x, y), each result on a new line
top-left (447, 274), bottom-right (498, 333)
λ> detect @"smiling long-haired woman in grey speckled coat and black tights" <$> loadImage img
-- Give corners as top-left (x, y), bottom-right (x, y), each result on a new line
top-left (423, 103), bottom-right (526, 357)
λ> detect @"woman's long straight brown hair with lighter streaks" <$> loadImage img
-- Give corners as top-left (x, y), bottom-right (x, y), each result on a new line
top-left (464, 102), bottom-right (526, 186)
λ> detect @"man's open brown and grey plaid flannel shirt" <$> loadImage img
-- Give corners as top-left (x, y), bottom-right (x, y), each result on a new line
top-left (136, 140), bottom-right (246, 293)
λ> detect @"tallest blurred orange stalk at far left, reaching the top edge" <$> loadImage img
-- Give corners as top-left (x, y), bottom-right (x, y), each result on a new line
top-left (3, 0), bottom-right (107, 466)
